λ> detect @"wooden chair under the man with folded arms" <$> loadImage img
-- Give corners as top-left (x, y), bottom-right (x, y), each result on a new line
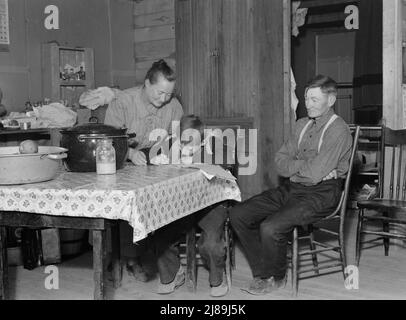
top-left (291, 126), bottom-right (360, 296)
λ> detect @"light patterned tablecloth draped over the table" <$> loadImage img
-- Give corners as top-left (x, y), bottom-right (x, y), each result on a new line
top-left (0, 165), bottom-right (241, 242)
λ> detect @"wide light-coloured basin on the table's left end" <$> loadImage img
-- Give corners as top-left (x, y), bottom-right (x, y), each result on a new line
top-left (0, 146), bottom-right (68, 185)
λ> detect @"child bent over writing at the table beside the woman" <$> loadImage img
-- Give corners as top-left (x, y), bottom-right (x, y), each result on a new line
top-left (151, 115), bottom-right (235, 297)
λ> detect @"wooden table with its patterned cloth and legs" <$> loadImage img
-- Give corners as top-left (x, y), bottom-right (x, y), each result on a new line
top-left (0, 165), bottom-right (241, 299)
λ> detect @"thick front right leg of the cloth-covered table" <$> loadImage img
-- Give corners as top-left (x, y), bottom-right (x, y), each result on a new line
top-left (93, 230), bottom-right (106, 300)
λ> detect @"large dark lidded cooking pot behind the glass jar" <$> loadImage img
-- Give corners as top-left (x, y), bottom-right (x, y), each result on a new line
top-left (61, 122), bottom-right (134, 172)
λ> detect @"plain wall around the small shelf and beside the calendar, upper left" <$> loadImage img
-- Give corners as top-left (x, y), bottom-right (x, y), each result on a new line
top-left (0, 0), bottom-right (135, 112)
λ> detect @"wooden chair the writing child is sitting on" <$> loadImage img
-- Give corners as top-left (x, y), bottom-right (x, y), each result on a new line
top-left (180, 121), bottom-right (240, 292)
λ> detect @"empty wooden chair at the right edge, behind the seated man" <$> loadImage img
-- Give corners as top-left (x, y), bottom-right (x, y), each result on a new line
top-left (355, 127), bottom-right (406, 266)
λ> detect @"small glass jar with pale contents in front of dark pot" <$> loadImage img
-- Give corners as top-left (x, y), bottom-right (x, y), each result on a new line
top-left (96, 138), bottom-right (116, 174)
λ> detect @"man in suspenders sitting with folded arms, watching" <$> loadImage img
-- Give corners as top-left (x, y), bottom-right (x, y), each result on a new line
top-left (230, 75), bottom-right (352, 295)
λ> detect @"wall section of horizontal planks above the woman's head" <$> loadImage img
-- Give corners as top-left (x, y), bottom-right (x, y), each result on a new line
top-left (134, 0), bottom-right (175, 84)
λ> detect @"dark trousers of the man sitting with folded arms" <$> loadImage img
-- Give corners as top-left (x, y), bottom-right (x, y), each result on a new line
top-left (230, 179), bottom-right (342, 279)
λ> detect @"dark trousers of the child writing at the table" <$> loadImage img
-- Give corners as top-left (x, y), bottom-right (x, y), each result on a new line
top-left (152, 204), bottom-right (228, 286)
